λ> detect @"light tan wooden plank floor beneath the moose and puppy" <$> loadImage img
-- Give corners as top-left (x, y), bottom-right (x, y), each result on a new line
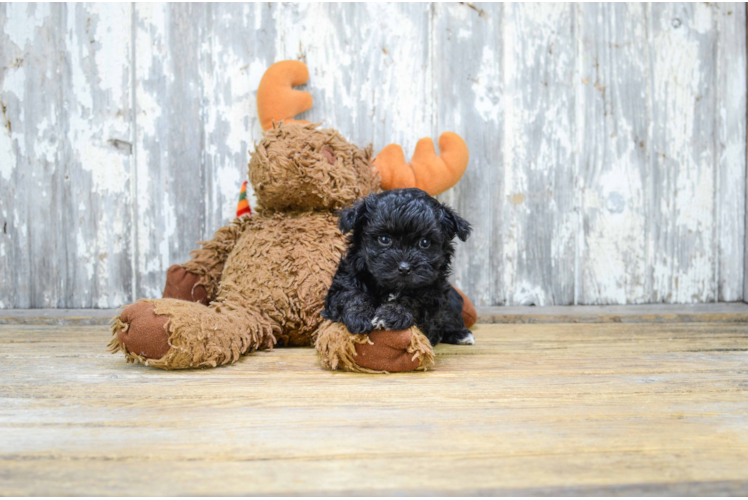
top-left (0, 314), bottom-right (748, 495)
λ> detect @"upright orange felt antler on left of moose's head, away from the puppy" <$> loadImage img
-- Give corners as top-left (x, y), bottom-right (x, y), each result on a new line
top-left (257, 61), bottom-right (312, 130)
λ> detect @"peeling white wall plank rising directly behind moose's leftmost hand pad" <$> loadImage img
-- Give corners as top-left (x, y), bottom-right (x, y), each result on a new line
top-left (133, 3), bottom-right (206, 297)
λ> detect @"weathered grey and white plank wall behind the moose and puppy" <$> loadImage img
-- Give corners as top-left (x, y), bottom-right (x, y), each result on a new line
top-left (0, 3), bottom-right (748, 308)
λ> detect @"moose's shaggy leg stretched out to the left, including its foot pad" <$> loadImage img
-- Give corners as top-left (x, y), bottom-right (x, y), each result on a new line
top-left (109, 296), bottom-right (280, 369)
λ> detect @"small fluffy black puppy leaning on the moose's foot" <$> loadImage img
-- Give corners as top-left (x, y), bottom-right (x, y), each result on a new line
top-left (322, 189), bottom-right (475, 345)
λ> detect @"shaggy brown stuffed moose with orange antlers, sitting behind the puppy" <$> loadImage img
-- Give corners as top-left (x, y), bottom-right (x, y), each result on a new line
top-left (110, 61), bottom-right (475, 373)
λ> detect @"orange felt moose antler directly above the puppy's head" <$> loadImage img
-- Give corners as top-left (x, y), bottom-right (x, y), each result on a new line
top-left (374, 132), bottom-right (470, 196)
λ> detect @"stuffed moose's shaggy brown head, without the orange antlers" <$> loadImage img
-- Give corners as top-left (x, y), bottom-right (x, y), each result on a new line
top-left (249, 124), bottom-right (379, 210)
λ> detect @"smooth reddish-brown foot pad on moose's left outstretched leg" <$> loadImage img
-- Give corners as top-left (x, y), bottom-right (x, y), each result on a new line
top-left (115, 302), bottom-right (171, 359)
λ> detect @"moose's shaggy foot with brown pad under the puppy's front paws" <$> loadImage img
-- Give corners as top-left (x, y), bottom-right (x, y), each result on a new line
top-left (315, 321), bottom-right (434, 373)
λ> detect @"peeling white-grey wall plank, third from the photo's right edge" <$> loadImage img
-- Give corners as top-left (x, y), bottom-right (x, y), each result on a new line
top-left (575, 3), bottom-right (652, 304)
